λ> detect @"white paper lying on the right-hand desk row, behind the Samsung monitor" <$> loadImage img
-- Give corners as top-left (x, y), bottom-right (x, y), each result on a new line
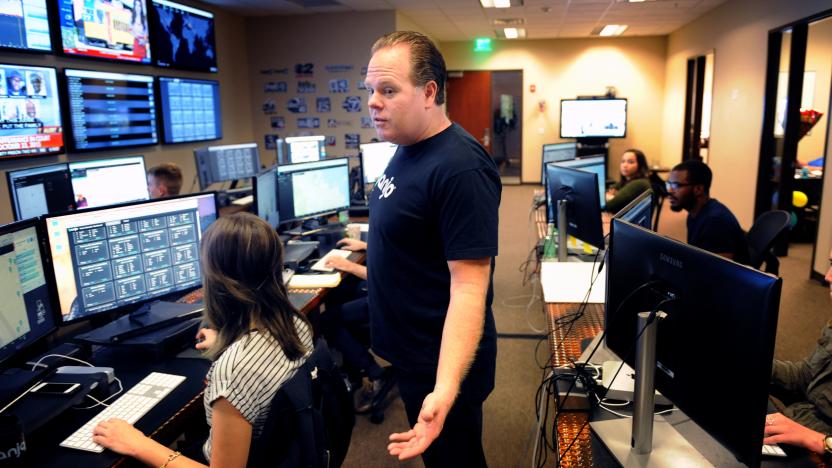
top-left (540, 262), bottom-right (607, 304)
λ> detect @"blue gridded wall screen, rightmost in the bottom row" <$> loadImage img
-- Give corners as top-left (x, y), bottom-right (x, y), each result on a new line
top-left (159, 76), bottom-right (222, 143)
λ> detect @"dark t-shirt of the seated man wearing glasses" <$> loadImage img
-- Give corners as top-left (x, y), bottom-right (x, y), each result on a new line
top-left (688, 198), bottom-right (749, 263)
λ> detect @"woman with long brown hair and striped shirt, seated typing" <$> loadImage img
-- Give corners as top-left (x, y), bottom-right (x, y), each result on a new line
top-left (93, 213), bottom-right (313, 468)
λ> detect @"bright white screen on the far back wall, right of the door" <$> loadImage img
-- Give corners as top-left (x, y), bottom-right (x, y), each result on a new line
top-left (560, 98), bottom-right (627, 138)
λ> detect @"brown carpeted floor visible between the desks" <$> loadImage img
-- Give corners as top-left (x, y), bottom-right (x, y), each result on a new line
top-left (344, 185), bottom-right (832, 468)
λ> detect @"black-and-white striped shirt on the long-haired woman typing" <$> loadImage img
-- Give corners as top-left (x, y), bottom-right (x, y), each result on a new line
top-left (202, 317), bottom-right (313, 460)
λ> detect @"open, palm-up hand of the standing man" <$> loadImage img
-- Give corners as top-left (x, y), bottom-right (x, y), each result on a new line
top-left (387, 392), bottom-right (453, 460)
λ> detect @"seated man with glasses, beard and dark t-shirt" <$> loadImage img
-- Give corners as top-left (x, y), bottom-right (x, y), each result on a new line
top-left (667, 160), bottom-right (749, 263)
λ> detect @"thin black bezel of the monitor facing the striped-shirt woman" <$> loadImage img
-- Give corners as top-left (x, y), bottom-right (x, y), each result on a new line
top-left (38, 191), bottom-right (220, 326)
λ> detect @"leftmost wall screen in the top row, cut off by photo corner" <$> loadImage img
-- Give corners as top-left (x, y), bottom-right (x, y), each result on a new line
top-left (0, 0), bottom-right (52, 52)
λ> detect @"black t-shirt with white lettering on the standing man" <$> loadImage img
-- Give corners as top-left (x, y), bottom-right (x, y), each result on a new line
top-left (367, 124), bottom-right (502, 373)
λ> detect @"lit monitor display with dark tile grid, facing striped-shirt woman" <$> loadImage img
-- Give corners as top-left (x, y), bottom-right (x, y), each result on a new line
top-left (43, 192), bottom-right (217, 323)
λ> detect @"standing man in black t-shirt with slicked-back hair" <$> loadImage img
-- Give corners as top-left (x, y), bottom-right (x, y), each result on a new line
top-left (365, 31), bottom-right (501, 467)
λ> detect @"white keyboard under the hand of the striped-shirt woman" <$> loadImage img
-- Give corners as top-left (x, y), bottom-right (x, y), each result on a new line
top-left (61, 372), bottom-right (185, 453)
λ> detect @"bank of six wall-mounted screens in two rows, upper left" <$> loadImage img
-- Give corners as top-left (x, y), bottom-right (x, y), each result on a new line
top-left (0, 0), bottom-right (222, 159)
